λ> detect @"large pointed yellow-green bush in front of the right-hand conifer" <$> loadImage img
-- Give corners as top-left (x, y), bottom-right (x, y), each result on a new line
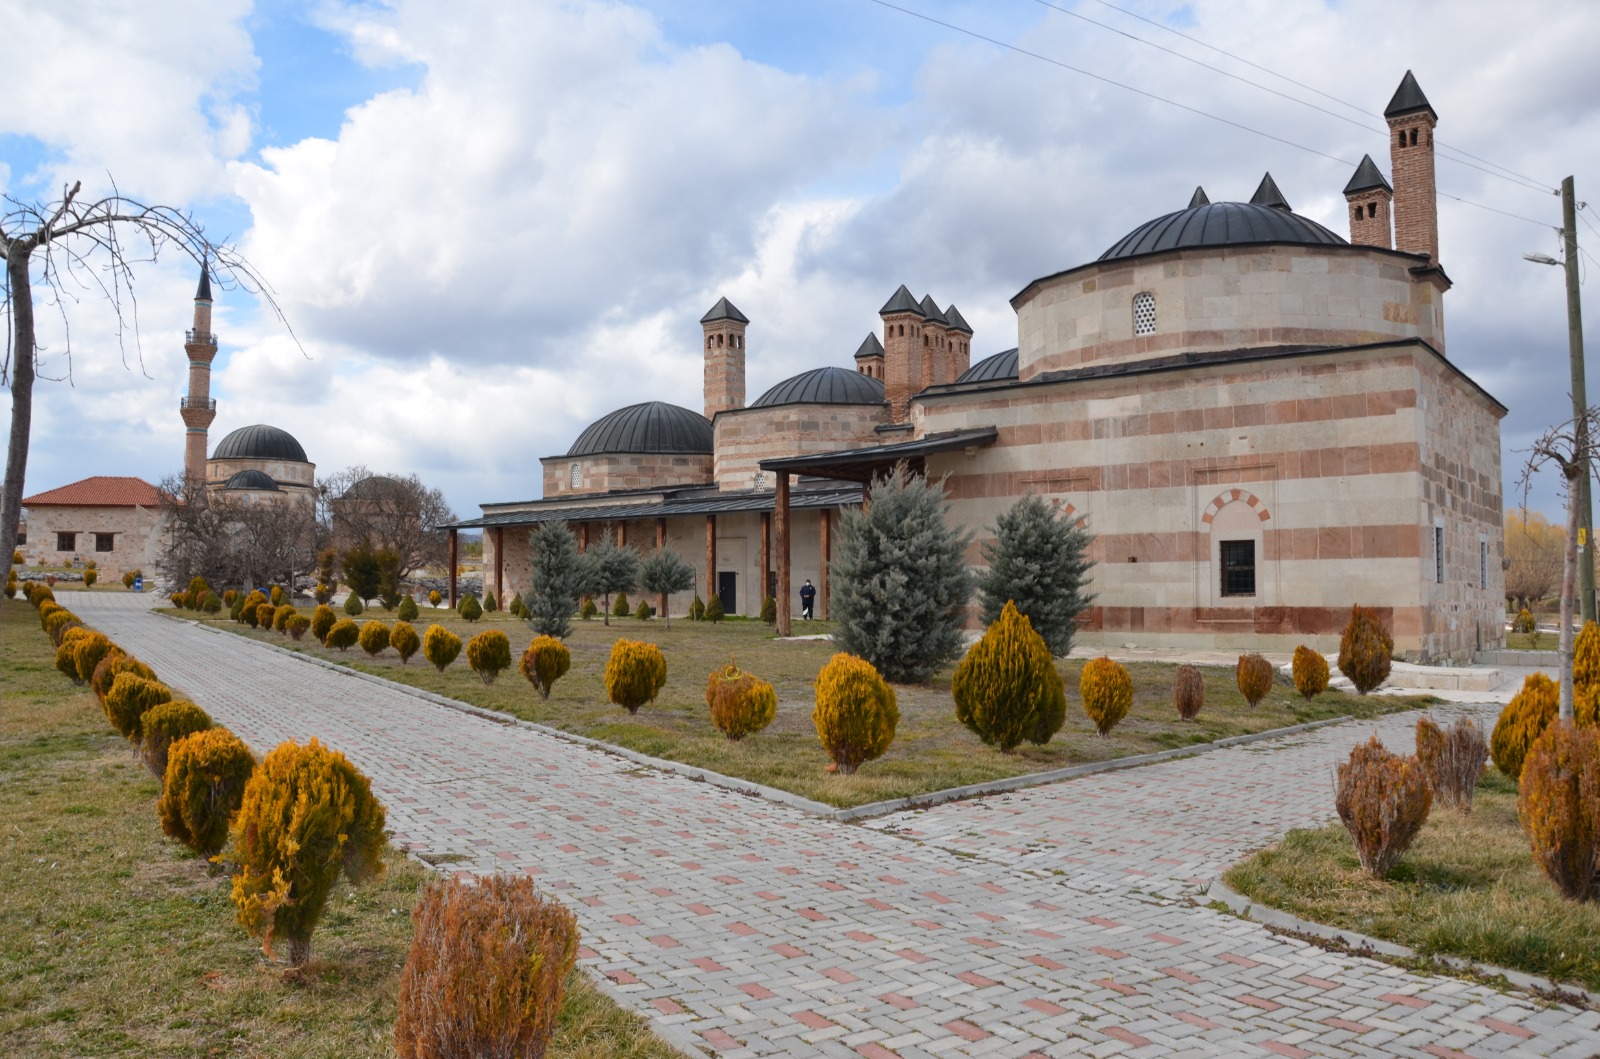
top-left (950, 603), bottom-right (1067, 753)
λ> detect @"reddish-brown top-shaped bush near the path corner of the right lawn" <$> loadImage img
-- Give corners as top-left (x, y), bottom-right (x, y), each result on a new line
top-left (1334, 736), bottom-right (1434, 878)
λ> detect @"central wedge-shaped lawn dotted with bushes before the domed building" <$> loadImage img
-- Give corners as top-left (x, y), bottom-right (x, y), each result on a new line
top-left (181, 608), bottom-right (1427, 806)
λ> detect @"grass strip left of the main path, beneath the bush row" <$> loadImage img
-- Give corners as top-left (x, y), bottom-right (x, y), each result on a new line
top-left (0, 600), bottom-right (678, 1059)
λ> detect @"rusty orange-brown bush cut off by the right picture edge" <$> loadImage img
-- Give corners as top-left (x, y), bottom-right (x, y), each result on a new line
top-left (1517, 721), bottom-right (1600, 901)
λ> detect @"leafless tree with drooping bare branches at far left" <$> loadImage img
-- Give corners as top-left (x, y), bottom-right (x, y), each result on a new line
top-left (0, 182), bottom-right (293, 585)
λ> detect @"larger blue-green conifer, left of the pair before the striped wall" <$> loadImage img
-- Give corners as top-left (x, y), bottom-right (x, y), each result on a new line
top-left (829, 464), bottom-right (973, 683)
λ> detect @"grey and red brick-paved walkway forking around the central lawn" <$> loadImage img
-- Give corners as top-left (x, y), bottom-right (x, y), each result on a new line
top-left (62, 593), bottom-right (1600, 1059)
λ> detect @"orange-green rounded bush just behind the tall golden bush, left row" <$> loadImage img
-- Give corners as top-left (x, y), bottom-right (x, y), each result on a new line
top-left (155, 728), bottom-right (256, 857)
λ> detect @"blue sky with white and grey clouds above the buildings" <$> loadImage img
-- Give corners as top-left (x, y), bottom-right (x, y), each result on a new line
top-left (0, 0), bottom-right (1600, 515)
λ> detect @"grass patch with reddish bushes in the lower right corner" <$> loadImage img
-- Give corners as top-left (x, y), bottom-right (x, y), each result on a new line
top-left (1224, 769), bottom-right (1600, 990)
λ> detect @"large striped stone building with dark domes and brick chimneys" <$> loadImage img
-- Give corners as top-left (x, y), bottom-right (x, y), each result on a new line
top-left (451, 72), bottom-right (1506, 659)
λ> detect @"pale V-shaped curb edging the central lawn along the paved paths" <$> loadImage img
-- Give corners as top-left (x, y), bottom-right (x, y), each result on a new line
top-left (184, 614), bottom-right (1388, 824)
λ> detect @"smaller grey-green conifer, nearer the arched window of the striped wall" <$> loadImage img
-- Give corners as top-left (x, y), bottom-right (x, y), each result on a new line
top-left (978, 494), bottom-right (1094, 657)
